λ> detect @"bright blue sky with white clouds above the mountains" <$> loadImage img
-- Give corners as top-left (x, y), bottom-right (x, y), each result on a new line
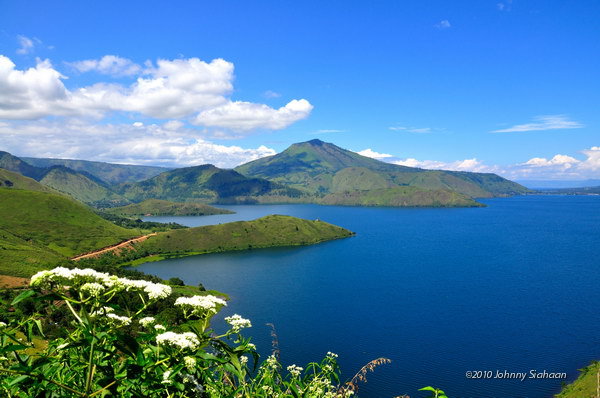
top-left (0, 0), bottom-right (600, 180)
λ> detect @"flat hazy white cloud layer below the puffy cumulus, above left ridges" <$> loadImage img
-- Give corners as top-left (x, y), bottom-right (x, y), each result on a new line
top-left (0, 119), bottom-right (276, 168)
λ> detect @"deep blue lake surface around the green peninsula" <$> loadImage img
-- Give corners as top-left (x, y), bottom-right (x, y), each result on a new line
top-left (139, 196), bottom-right (600, 398)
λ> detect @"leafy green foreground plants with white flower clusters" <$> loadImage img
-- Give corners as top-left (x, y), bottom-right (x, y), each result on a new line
top-left (0, 268), bottom-right (387, 398)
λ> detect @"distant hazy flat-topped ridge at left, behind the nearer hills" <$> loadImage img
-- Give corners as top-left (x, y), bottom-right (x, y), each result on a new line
top-left (22, 157), bottom-right (170, 184)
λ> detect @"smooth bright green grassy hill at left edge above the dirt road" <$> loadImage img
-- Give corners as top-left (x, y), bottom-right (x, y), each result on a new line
top-left (0, 188), bottom-right (141, 266)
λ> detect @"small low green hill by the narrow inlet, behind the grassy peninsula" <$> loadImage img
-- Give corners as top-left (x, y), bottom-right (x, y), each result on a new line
top-left (104, 199), bottom-right (233, 216)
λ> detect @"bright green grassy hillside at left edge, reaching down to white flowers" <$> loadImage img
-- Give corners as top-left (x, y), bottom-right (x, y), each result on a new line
top-left (0, 188), bottom-right (141, 275)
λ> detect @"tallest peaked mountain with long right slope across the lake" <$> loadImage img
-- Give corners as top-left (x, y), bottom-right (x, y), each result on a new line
top-left (235, 140), bottom-right (529, 206)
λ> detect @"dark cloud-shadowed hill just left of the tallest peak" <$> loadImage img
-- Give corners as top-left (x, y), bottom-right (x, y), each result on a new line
top-left (115, 164), bottom-right (300, 203)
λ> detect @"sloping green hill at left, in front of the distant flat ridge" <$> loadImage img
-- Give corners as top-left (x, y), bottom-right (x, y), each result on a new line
top-left (40, 166), bottom-right (129, 206)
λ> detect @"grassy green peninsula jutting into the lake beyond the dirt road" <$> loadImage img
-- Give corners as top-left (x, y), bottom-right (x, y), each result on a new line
top-left (139, 215), bottom-right (353, 255)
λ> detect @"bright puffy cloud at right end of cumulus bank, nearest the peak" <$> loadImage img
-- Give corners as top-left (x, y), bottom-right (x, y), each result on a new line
top-left (193, 99), bottom-right (313, 131)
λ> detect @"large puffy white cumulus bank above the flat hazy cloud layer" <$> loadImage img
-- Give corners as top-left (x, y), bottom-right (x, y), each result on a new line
top-left (0, 56), bottom-right (313, 132)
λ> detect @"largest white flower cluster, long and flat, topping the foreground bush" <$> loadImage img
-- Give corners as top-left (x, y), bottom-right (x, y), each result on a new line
top-left (31, 267), bottom-right (172, 299)
